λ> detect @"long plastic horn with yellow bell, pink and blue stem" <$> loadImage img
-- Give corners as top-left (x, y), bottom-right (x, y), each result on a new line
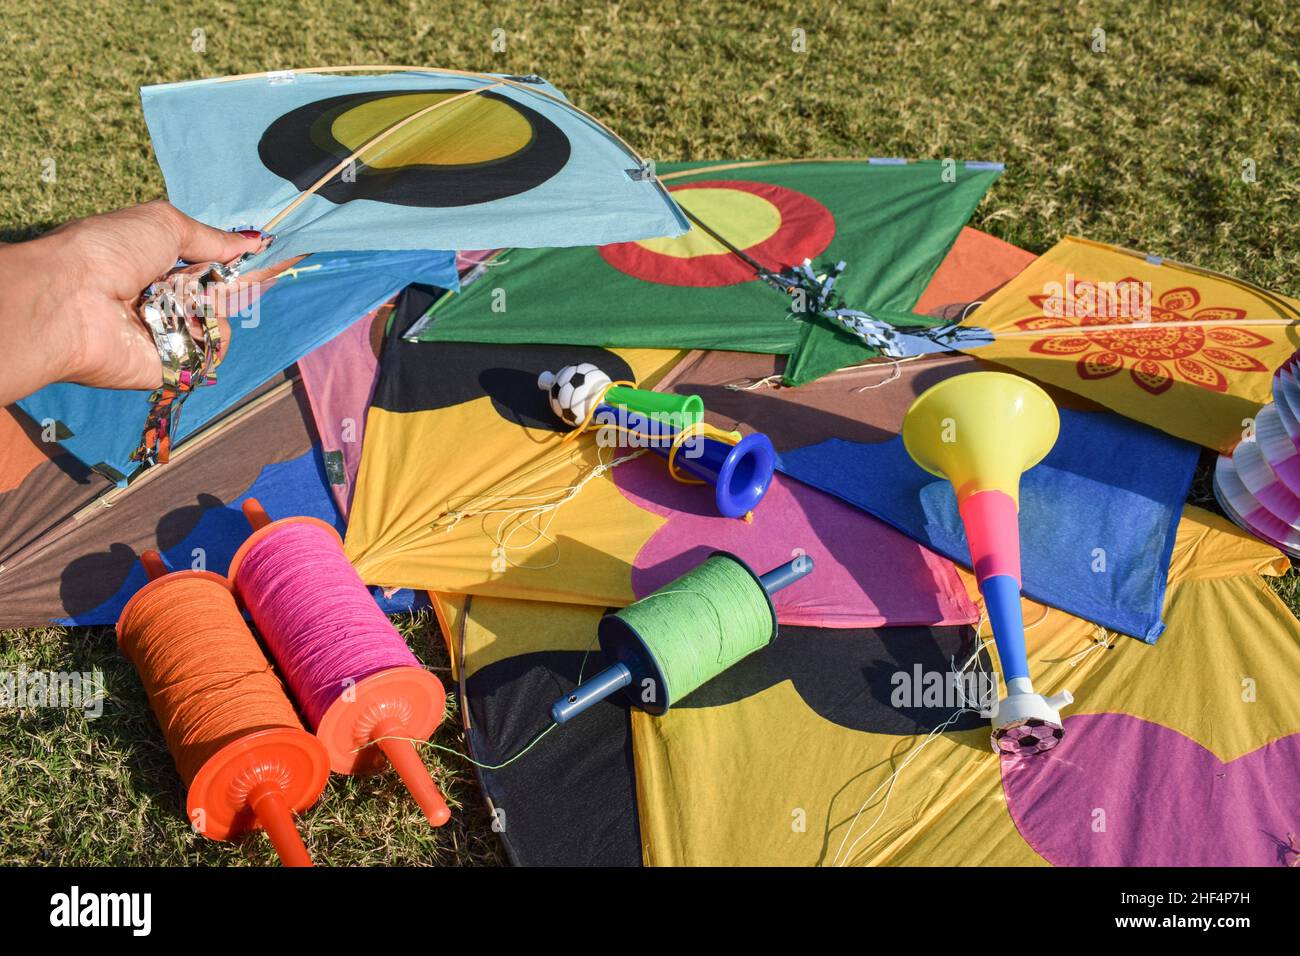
top-left (902, 372), bottom-right (1074, 753)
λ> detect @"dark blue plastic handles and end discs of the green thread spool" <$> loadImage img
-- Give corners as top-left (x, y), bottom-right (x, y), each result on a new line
top-left (551, 551), bottom-right (813, 723)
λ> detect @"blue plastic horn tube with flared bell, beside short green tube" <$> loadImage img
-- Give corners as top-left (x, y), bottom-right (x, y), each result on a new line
top-left (592, 405), bottom-right (776, 518)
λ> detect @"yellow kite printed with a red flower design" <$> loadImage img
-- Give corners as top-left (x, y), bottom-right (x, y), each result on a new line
top-left (971, 237), bottom-right (1300, 451)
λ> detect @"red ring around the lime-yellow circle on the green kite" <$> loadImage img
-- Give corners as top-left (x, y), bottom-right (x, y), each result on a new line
top-left (599, 179), bottom-right (835, 287)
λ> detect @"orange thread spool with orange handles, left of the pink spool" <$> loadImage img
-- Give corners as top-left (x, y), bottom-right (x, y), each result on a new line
top-left (117, 551), bottom-right (329, 866)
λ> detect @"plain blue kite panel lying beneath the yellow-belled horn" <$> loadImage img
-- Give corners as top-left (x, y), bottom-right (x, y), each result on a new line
top-left (777, 408), bottom-right (1200, 644)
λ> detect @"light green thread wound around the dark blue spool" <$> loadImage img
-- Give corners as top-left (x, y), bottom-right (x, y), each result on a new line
top-left (618, 554), bottom-right (775, 702)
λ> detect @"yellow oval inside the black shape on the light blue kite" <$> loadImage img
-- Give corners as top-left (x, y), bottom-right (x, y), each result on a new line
top-left (330, 91), bottom-right (533, 169)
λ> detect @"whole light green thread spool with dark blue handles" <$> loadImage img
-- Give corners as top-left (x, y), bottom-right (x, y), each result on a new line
top-left (551, 551), bottom-right (813, 723)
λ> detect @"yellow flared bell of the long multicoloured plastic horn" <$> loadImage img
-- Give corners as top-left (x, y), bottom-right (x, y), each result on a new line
top-left (902, 372), bottom-right (1061, 505)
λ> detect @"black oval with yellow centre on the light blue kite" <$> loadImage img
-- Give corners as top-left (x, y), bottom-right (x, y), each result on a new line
top-left (257, 88), bottom-right (571, 208)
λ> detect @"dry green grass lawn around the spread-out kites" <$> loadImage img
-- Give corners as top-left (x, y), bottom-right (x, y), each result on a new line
top-left (0, 0), bottom-right (1300, 864)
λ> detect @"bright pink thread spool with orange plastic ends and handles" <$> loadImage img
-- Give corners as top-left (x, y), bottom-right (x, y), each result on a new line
top-left (229, 498), bottom-right (451, 826)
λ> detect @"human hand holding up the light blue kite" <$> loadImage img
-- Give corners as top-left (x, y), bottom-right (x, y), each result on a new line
top-left (0, 200), bottom-right (263, 402)
